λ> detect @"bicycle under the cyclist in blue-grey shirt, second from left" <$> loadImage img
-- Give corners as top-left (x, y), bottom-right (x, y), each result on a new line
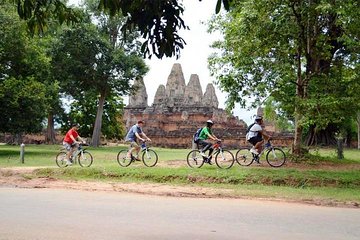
top-left (117, 142), bottom-right (158, 167)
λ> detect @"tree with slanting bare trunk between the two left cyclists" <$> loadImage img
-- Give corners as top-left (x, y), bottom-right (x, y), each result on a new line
top-left (52, 24), bottom-right (147, 146)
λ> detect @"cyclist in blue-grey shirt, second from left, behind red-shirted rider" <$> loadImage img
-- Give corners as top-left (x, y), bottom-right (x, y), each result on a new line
top-left (125, 120), bottom-right (151, 160)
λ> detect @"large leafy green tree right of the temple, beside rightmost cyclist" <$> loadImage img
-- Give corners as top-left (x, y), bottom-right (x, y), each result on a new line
top-left (209, 0), bottom-right (360, 154)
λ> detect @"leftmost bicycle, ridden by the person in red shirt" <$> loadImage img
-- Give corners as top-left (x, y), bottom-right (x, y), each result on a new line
top-left (55, 143), bottom-right (94, 168)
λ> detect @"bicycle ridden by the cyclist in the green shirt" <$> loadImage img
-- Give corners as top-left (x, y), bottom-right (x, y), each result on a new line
top-left (186, 141), bottom-right (235, 169)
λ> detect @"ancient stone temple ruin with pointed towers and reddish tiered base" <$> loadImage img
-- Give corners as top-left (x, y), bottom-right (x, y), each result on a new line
top-left (124, 64), bottom-right (292, 148)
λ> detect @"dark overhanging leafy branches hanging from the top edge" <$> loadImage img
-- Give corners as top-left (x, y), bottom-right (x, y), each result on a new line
top-left (11, 0), bottom-right (233, 58)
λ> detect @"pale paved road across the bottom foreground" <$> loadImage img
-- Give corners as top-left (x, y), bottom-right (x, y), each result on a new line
top-left (0, 187), bottom-right (360, 240)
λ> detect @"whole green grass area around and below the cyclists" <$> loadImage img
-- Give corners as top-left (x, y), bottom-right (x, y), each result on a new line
top-left (0, 145), bottom-right (360, 204)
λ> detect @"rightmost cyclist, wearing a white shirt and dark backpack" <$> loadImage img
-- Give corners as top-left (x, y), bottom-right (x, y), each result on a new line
top-left (246, 116), bottom-right (270, 155)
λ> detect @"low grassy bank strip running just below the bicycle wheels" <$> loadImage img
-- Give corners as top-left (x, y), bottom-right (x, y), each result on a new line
top-left (34, 167), bottom-right (360, 190)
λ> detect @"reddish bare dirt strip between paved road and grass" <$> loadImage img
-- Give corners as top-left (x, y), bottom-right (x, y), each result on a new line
top-left (0, 167), bottom-right (359, 208)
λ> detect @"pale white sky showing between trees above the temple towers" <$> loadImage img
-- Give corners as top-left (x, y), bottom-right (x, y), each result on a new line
top-left (70, 0), bottom-right (256, 123)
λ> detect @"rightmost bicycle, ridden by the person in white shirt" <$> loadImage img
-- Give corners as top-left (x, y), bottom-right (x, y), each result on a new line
top-left (236, 140), bottom-right (286, 167)
